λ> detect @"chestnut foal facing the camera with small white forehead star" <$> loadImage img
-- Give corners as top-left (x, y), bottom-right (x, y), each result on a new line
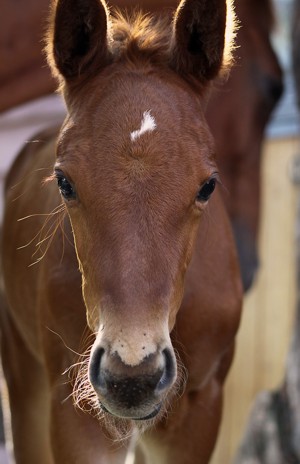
top-left (1, 0), bottom-right (241, 464)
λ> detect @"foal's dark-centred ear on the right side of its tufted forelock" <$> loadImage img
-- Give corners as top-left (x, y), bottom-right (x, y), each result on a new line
top-left (173, 0), bottom-right (226, 83)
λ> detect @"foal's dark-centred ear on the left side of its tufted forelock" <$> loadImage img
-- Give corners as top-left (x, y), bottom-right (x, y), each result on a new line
top-left (48, 0), bottom-right (109, 81)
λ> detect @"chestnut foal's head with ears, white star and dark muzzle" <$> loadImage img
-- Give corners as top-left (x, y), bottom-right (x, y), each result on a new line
top-left (49, 0), bottom-right (234, 420)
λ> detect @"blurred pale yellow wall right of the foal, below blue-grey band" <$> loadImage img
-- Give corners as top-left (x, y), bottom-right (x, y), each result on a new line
top-left (212, 137), bottom-right (300, 464)
